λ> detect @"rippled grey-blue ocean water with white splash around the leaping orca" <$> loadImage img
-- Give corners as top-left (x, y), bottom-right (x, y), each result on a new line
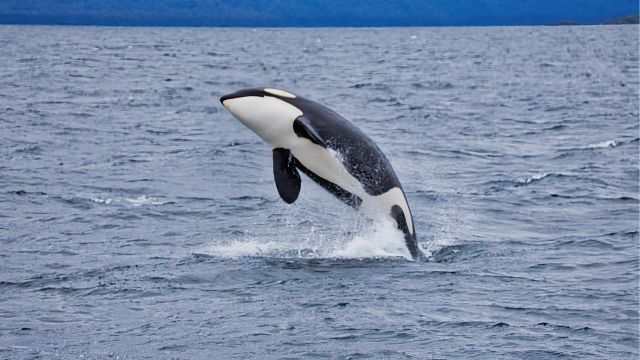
top-left (0, 26), bottom-right (639, 359)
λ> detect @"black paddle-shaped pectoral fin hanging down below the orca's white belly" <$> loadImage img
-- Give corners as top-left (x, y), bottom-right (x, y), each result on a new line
top-left (273, 148), bottom-right (301, 204)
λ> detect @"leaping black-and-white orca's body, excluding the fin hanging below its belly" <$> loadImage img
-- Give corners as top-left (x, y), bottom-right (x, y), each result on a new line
top-left (220, 88), bottom-right (424, 259)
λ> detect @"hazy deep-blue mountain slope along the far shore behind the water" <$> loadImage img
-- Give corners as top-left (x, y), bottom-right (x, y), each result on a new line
top-left (0, 0), bottom-right (638, 26)
